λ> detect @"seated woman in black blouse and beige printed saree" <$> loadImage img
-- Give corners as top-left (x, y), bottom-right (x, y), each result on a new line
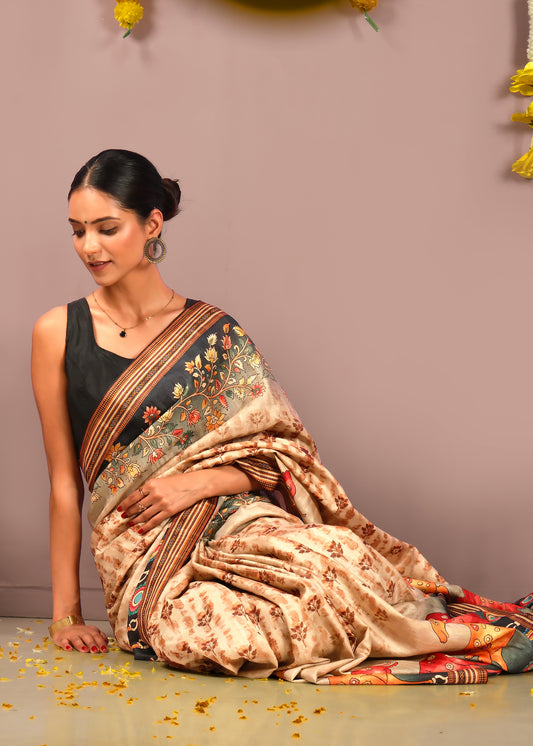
top-left (32, 150), bottom-right (533, 684)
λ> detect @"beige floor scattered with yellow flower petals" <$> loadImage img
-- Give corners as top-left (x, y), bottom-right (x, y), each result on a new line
top-left (0, 618), bottom-right (533, 746)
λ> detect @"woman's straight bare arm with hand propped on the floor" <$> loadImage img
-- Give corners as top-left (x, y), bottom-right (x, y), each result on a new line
top-left (32, 307), bottom-right (107, 652)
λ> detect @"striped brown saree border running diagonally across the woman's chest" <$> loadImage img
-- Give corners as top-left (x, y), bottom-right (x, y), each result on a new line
top-left (80, 301), bottom-right (225, 489)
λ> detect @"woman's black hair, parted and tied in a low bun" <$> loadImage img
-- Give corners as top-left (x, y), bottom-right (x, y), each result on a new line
top-left (68, 150), bottom-right (181, 220)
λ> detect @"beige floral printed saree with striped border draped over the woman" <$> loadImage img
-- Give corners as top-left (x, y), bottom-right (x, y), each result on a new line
top-left (76, 301), bottom-right (533, 685)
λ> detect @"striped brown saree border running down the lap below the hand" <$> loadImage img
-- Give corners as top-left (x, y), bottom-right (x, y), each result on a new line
top-left (137, 497), bottom-right (218, 641)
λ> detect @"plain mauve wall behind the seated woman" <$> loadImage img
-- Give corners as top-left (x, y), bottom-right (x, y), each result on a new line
top-left (0, 0), bottom-right (533, 616)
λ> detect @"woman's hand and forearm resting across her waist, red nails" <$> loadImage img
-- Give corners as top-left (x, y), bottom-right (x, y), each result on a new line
top-left (117, 465), bottom-right (257, 534)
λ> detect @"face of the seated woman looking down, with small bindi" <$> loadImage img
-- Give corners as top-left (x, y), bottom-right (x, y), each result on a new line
top-left (69, 187), bottom-right (161, 285)
